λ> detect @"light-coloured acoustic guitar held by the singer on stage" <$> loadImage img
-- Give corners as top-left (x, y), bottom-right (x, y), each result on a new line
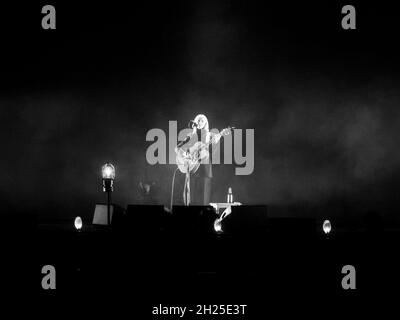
top-left (176, 127), bottom-right (233, 174)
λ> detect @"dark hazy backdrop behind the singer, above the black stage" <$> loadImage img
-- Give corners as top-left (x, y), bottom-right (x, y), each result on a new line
top-left (0, 0), bottom-right (400, 223)
